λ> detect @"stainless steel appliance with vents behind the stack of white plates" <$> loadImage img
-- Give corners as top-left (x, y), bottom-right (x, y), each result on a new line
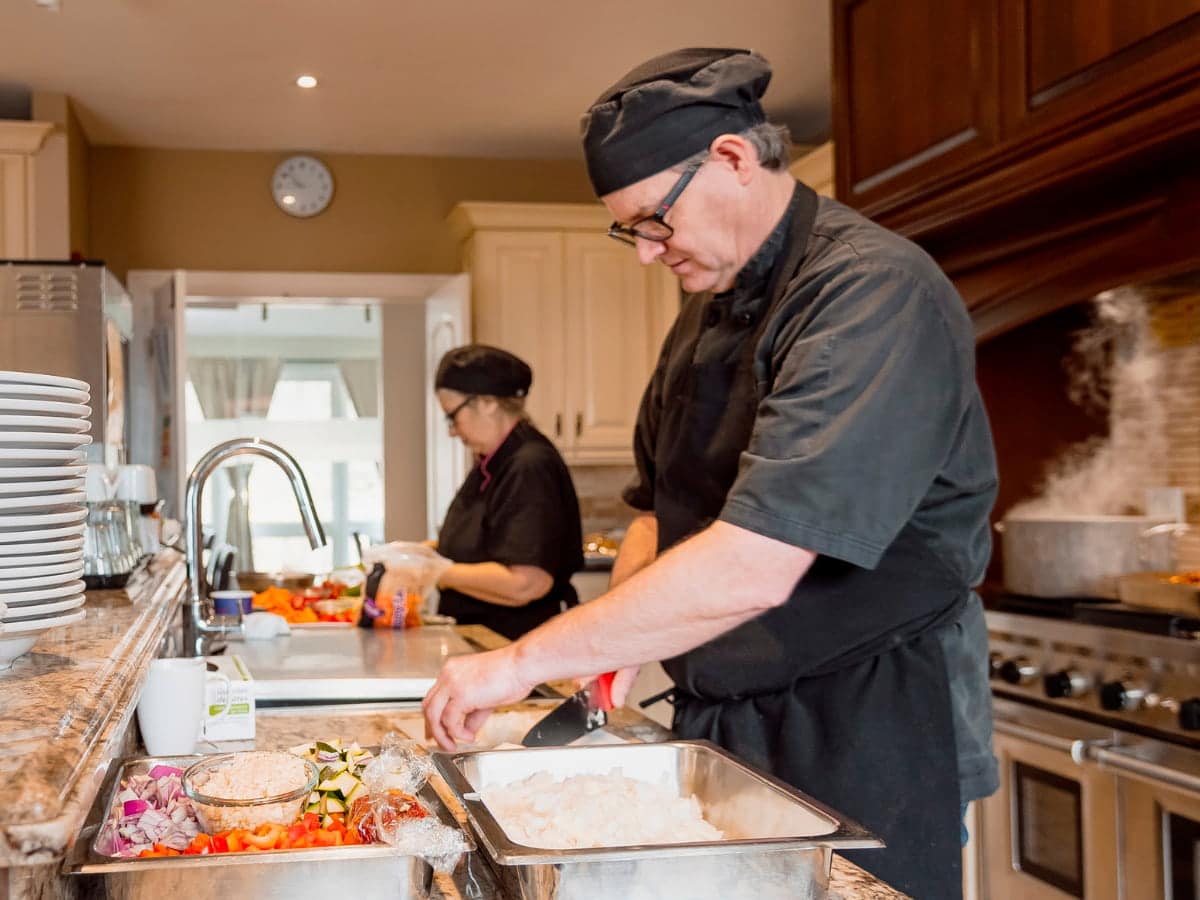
top-left (0, 259), bottom-right (133, 466)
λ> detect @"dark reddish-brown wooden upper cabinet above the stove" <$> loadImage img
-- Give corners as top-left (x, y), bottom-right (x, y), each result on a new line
top-left (833, 0), bottom-right (1200, 238)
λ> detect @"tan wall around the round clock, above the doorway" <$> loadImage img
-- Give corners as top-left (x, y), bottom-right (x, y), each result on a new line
top-left (88, 146), bottom-right (594, 278)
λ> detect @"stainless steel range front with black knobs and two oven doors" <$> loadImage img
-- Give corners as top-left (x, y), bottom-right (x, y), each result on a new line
top-left (977, 601), bottom-right (1200, 900)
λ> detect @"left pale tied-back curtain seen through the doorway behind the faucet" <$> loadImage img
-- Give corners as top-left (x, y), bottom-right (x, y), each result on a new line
top-left (187, 356), bottom-right (283, 571)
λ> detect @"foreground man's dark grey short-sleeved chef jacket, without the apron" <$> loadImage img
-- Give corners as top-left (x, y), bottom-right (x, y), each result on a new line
top-left (625, 192), bottom-right (996, 798)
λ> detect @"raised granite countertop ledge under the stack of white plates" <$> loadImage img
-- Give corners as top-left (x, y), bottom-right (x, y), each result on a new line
top-left (0, 551), bottom-right (186, 868)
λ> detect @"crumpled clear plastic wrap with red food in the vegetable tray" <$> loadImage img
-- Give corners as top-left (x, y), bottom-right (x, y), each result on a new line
top-left (347, 733), bottom-right (472, 872)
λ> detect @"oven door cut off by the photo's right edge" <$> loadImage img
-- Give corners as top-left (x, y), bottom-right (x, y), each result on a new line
top-left (1093, 742), bottom-right (1200, 900)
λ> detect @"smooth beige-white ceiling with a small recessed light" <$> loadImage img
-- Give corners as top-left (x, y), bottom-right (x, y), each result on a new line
top-left (0, 0), bottom-right (830, 158)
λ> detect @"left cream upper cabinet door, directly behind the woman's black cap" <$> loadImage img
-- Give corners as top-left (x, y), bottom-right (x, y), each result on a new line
top-left (468, 232), bottom-right (569, 446)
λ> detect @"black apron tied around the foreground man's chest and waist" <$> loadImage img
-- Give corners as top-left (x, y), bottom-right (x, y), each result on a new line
top-left (654, 186), bottom-right (968, 900)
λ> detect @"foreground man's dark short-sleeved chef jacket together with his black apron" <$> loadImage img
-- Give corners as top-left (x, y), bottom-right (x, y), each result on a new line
top-left (625, 185), bottom-right (996, 898)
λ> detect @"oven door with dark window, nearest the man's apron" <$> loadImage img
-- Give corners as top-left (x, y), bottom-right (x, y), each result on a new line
top-left (980, 697), bottom-right (1120, 900)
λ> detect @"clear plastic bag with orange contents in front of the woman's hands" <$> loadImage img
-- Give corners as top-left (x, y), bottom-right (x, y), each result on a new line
top-left (359, 541), bottom-right (454, 628)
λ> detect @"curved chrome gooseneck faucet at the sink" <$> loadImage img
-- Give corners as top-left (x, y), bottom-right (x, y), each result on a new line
top-left (184, 438), bottom-right (325, 656)
